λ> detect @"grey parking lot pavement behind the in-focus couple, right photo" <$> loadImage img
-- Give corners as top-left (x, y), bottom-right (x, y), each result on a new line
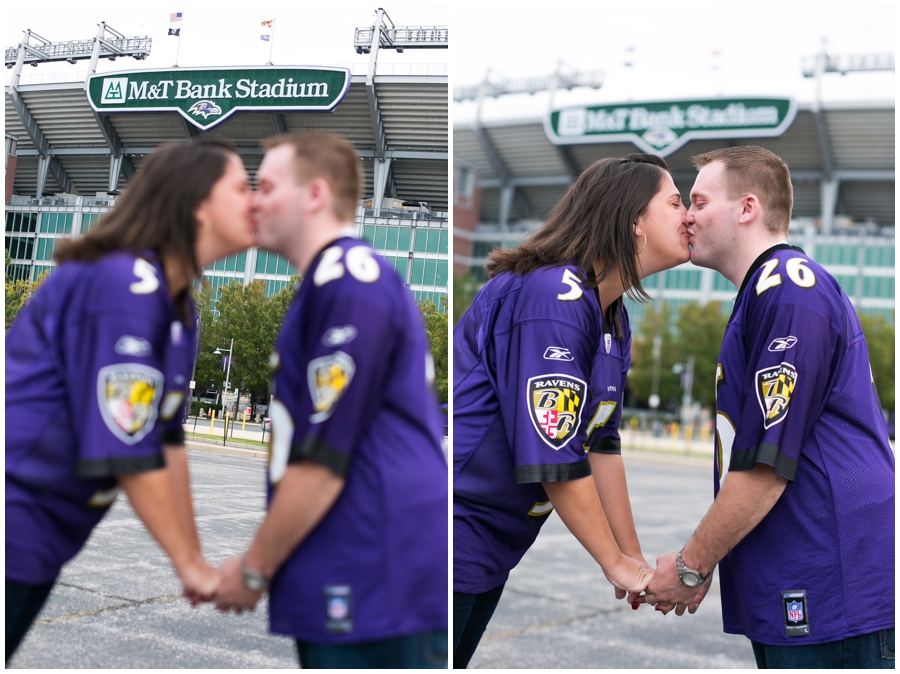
top-left (469, 453), bottom-right (756, 669)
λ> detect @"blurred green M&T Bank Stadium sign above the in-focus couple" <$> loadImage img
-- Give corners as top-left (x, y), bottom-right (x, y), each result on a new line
top-left (544, 98), bottom-right (797, 157)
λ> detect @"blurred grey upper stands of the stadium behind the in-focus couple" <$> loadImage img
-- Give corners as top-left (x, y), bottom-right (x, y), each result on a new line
top-left (453, 101), bottom-right (895, 228)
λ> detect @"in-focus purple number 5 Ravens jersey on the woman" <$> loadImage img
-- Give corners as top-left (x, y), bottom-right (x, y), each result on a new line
top-left (453, 265), bottom-right (631, 594)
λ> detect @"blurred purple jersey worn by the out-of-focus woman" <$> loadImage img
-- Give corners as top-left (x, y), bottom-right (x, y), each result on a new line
top-left (6, 253), bottom-right (193, 585)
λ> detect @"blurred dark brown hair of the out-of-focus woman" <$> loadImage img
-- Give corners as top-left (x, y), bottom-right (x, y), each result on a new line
top-left (54, 138), bottom-right (236, 276)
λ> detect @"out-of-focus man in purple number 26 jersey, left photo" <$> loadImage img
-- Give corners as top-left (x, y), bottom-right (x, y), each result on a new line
top-left (217, 133), bottom-right (448, 668)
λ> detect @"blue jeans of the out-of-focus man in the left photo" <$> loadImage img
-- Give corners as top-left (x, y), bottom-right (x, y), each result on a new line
top-left (297, 630), bottom-right (447, 669)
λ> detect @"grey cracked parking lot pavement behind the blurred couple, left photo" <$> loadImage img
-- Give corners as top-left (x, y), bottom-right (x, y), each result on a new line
top-left (8, 450), bottom-right (297, 669)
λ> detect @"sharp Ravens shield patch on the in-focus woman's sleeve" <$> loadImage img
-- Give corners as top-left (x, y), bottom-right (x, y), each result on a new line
top-left (527, 374), bottom-right (587, 449)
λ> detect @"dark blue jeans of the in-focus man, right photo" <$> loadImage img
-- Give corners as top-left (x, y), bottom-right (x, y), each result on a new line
top-left (751, 627), bottom-right (894, 669)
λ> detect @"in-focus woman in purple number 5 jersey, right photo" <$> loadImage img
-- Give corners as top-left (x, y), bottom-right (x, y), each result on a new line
top-left (453, 154), bottom-right (690, 668)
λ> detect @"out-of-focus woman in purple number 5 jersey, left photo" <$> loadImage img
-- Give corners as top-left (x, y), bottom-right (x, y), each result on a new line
top-left (6, 140), bottom-right (253, 661)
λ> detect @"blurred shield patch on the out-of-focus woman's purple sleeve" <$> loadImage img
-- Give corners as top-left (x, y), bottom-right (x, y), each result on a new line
top-left (97, 363), bottom-right (163, 445)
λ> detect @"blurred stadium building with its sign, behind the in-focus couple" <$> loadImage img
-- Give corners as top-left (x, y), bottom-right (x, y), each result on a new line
top-left (453, 60), bottom-right (895, 328)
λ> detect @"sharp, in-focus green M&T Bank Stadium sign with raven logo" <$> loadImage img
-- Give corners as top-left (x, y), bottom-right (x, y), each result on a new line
top-left (88, 67), bottom-right (350, 129)
